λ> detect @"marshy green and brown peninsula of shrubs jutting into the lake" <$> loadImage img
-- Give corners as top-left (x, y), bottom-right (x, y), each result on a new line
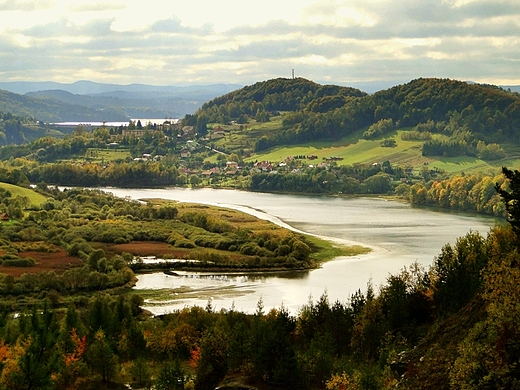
top-left (0, 185), bottom-right (360, 305)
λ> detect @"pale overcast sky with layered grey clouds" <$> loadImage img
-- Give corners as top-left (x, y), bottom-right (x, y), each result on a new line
top-left (0, 0), bottom-right (520, 85)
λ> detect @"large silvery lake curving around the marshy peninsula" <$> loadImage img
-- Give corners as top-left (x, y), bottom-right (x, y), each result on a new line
top-left (97, 188), bottom-right (497, 314)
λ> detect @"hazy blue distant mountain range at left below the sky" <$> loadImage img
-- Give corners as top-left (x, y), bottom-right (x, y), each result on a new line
top-left (0, 81), bottom-right (241, 122)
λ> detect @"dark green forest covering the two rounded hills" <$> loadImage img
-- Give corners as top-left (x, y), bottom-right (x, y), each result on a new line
top-left (195, 78), bottom-right (520, 150)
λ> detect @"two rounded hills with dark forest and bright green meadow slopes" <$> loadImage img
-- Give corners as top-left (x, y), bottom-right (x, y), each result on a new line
top-left (189, 79), bottom-right (520, 171)
